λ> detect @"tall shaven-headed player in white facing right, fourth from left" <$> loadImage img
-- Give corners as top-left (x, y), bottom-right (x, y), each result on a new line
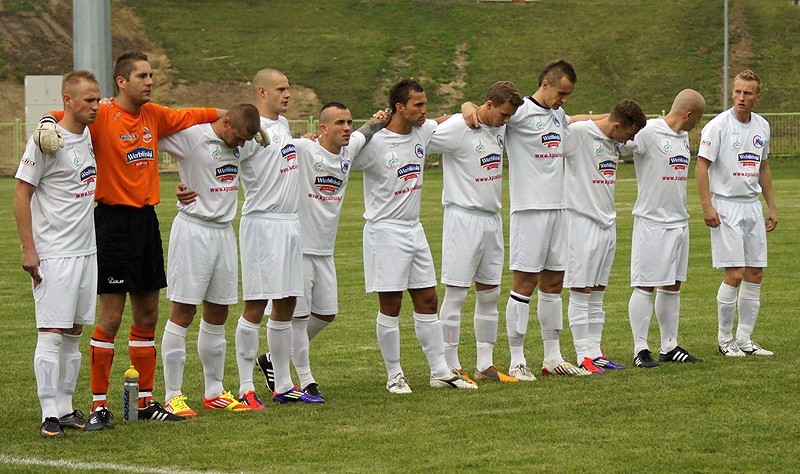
top-left (236, 68), bottom-right (324, 407)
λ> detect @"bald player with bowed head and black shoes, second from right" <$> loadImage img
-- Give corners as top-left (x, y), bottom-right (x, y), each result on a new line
top-left (621, 89), bottom-right (706, 368)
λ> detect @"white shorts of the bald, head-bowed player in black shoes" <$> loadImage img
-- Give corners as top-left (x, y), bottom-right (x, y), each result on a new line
top-left (631, 217), bottom-right (689, 287)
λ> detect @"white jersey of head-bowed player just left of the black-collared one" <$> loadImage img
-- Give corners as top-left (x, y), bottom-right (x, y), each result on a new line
top-left (427, 114), bottom-right (506, 213)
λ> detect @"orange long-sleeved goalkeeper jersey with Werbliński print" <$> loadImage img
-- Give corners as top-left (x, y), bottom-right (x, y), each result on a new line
top-left (51, 102), bottom-right (217, 207)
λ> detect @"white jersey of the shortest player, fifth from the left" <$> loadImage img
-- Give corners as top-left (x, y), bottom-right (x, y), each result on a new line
top-left (295, 131), bottom-right (367, 255)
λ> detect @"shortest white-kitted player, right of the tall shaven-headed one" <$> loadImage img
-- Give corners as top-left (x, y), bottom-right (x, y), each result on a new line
top-left (257, 102), bottom-right (387, 398)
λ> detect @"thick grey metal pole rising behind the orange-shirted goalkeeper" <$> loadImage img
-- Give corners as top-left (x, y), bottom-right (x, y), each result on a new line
top-left (72, 0), bottom-right (114, 97)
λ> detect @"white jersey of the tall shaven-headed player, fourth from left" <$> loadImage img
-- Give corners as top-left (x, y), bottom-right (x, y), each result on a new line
top-left (239, 116), bottom-right (300, 216)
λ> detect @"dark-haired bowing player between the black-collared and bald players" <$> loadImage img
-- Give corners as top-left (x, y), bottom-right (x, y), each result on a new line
top-left (564, 100), bottom-right (647, 374)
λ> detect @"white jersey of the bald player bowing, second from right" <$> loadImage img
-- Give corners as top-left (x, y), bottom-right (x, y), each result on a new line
top-left (620, 117), bottom-right (691, 228)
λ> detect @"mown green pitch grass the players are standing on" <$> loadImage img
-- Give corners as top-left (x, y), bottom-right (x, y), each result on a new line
top-left (0, 160), bottom-right (800, 472)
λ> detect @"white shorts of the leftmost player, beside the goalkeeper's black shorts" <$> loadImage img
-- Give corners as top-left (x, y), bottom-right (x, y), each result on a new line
top-left (33, 253), bottom-right (97, 329)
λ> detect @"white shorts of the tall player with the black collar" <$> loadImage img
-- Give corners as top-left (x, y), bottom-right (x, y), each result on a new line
top-left (509, 209), bottom-right (567, 273)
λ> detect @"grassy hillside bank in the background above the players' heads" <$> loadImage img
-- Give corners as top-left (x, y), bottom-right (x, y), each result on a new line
top-left (126, 0), bottom-right (800, 116)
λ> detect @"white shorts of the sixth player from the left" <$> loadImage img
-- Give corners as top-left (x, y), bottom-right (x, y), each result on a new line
top-left (364, 221), bottom-right (436, 293)
